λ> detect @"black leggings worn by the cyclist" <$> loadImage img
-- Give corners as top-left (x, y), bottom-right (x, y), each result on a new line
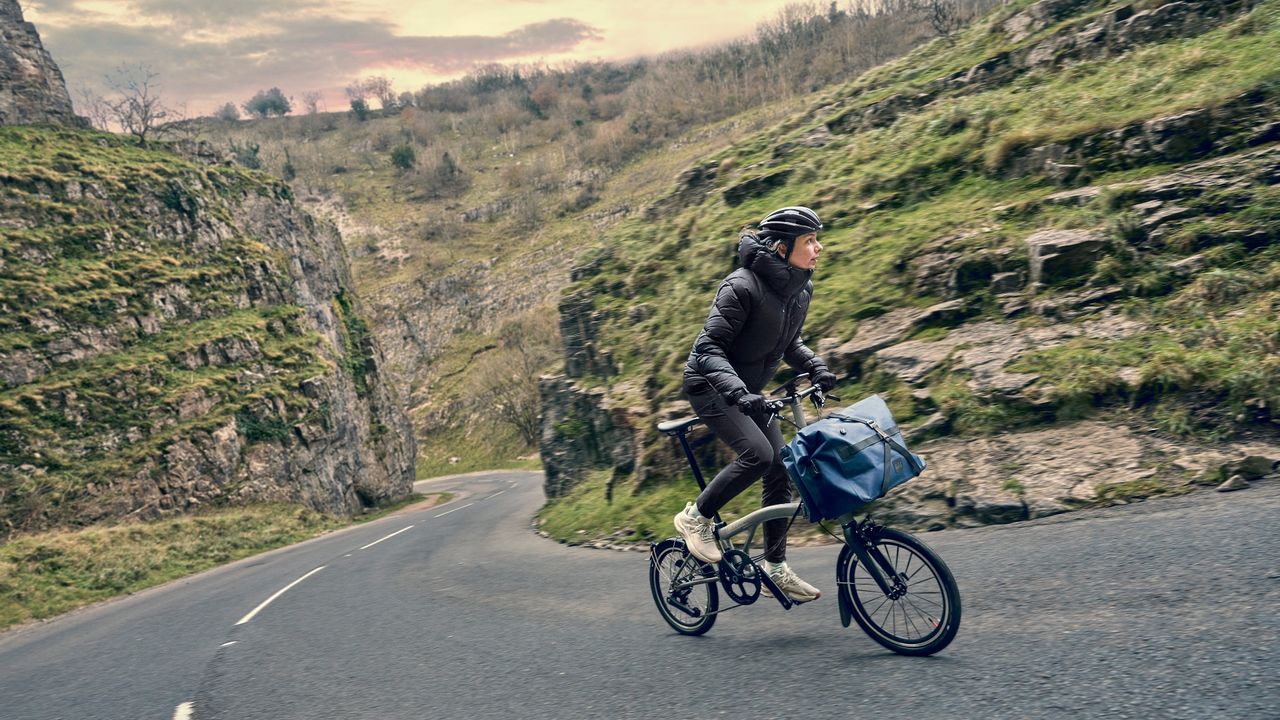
top-left (689, 388), bottom-right (791, 562)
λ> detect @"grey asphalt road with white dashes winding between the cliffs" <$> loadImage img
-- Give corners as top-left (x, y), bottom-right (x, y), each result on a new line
top-left (0, 473), bottom-right (1280, 720)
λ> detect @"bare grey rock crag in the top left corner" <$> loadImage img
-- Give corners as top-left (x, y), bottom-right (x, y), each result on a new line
top-left (0, 0), bottom-right (88, 127)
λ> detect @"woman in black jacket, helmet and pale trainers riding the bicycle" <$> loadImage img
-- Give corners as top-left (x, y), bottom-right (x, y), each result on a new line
top-left (675, 206), bottom-right (836, 602)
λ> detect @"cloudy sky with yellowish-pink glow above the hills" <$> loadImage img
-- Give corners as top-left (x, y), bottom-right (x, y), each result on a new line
top-left (19, 0), bottom-right (794, 115)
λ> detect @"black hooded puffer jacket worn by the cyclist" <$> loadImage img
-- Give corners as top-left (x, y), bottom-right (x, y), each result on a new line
top-left (685, 234), bottom-right (827, 402)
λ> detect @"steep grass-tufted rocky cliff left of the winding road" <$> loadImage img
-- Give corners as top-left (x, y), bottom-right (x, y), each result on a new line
top-left (0, 127), bottom-right (415, 533)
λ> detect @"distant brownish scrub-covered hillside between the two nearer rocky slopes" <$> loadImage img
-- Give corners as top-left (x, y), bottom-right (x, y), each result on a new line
top-left (189, 0), bottom-right (992, 477)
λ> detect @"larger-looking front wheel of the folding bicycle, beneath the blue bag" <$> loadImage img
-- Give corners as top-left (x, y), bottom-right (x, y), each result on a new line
top-left (836, 528), bottom-right (960, 656)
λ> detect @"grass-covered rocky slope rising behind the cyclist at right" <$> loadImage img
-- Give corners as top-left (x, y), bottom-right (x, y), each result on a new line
top-left (543, 0), bottom-right (1280, 534)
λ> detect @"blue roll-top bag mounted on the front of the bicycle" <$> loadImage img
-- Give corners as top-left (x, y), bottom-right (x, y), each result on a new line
top-left (782, 395), bottom-right (924, 523)
